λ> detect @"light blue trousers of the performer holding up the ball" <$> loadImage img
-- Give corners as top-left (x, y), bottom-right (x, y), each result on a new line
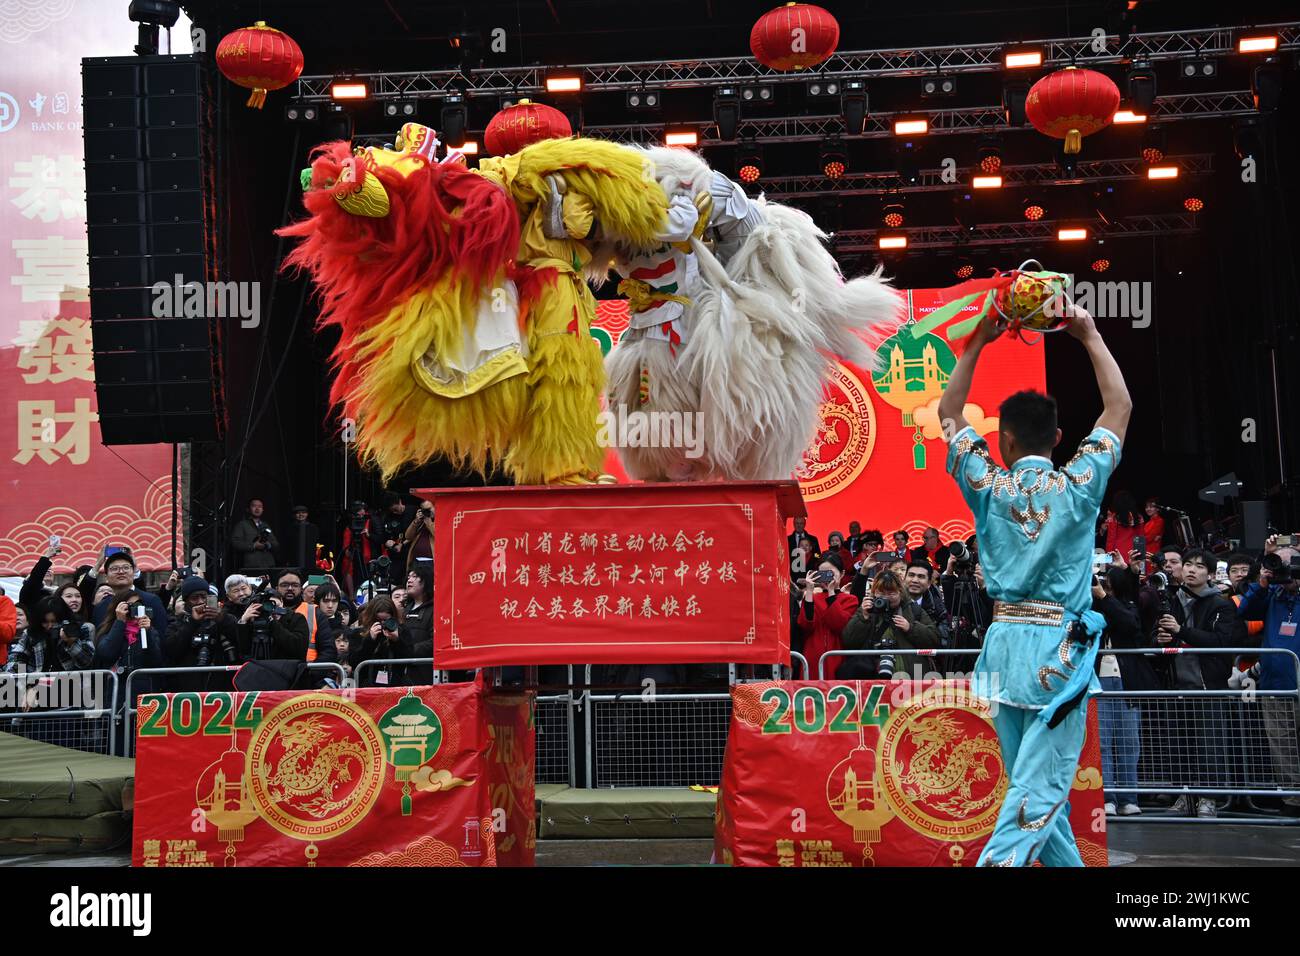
top-left (979, 701), bottom-right (1088, 866)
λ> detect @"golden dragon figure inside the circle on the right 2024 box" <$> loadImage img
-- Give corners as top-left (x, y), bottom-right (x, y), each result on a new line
top-left (898, 714), bottom-right (1002, 817)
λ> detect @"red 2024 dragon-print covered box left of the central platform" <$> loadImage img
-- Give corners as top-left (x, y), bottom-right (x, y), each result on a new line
top-left (131, 683), bottom-right (537, 866)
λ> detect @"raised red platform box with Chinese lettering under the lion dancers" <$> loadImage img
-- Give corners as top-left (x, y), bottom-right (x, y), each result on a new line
top-left (413, 481), bottom-right (803, 669)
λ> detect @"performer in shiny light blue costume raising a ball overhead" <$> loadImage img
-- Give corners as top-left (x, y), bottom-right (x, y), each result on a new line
top-left (939, 306), bottom-right (1132, 866)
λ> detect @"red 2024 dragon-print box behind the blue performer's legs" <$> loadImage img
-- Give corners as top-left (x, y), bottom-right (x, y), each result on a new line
top-left (714, 680), bottom-right (1106, 866)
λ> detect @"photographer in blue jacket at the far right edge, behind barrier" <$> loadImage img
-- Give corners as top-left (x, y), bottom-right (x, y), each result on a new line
top-left (1229, 535), bottom-right (1300, 817)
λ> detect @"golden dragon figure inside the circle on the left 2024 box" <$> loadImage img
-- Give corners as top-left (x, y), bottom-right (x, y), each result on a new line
top-left (267, 715), bottom-right (367, 818)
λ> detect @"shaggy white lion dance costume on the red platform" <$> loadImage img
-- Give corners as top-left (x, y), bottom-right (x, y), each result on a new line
top-left (597, 147), bottom-right (902, 481)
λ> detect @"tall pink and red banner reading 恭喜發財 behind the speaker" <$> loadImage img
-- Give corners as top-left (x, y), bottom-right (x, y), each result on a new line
top-left (0, 0), bottom-right (180, 574)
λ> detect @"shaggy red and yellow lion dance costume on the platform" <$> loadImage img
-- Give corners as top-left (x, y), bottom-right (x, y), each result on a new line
top-left (282, 124), bottom-right (667, 484)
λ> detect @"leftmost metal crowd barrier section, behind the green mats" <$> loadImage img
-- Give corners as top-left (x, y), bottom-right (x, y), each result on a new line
top-left (0, 670), bottom-right (117, 756)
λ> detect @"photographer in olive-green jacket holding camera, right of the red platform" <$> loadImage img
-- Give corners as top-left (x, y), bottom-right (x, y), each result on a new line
top-left (839, 571), bottom-right (939, 680)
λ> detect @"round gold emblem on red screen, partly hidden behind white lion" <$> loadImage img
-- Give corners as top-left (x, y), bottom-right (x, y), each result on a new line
top-left (794, 363), bottom-right (876, 501)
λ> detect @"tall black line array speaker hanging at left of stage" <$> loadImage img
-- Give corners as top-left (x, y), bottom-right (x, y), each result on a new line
top-left (82, 55), bottom-right (225, 445)
